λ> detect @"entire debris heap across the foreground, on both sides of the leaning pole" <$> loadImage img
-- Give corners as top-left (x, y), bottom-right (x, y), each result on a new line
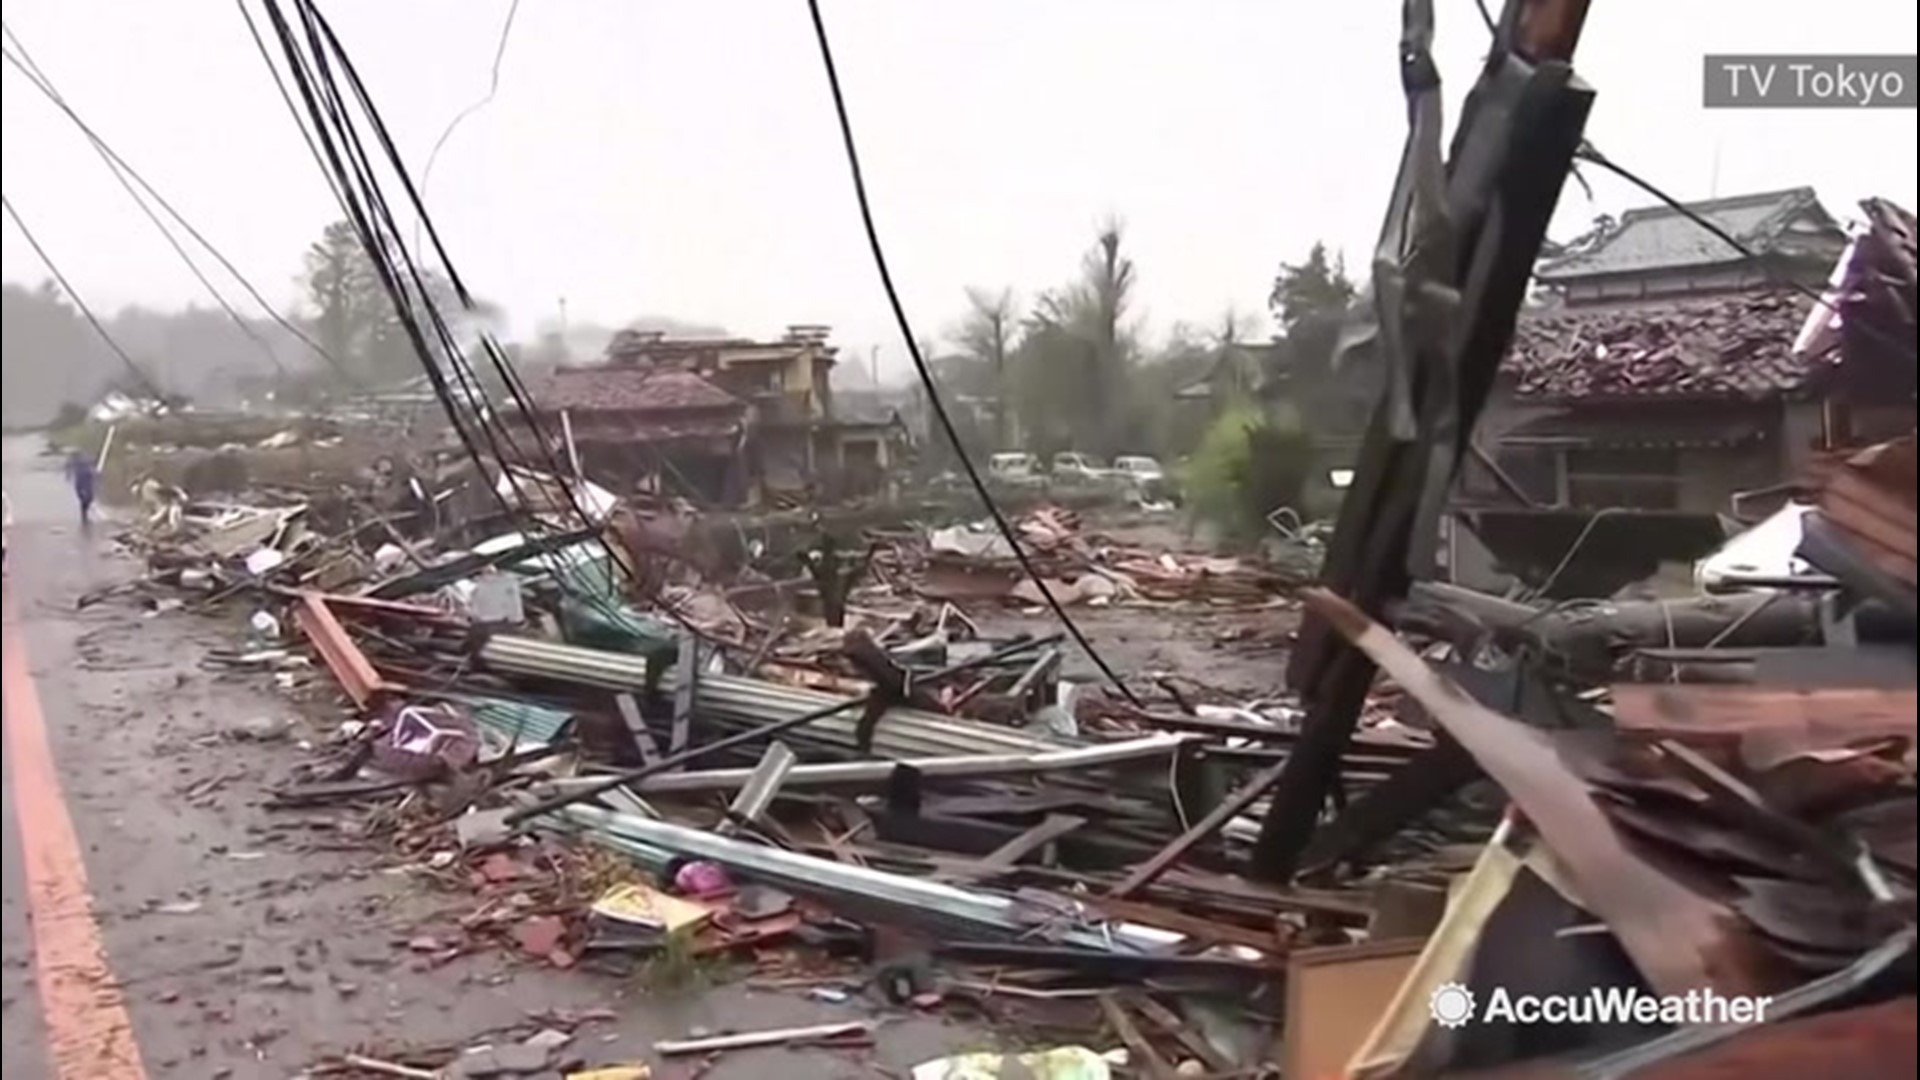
top-left (105, 405), bottom-right (1916, 1076)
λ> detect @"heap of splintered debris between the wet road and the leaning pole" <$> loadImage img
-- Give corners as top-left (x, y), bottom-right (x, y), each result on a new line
top-left (108, 477), bottom-right (1397, 1074)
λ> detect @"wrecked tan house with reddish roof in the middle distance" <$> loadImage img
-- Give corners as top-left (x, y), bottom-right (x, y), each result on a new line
top-left (534, 327), bottom-right (906, 505)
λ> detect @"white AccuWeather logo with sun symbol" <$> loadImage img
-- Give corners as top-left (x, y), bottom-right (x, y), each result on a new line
top-left (1427, 982), bottom-right (1774, 1028)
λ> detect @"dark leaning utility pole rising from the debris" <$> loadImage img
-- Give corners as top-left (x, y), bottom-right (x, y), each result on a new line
top-left (1248, 0), bottom-right (1594, 880)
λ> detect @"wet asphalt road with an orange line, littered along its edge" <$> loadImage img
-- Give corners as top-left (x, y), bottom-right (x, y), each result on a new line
top-left (0, 438), bottom-right (975, 1080)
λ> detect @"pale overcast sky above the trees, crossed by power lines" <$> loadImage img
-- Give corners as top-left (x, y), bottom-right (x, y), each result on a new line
top-left (0, 0), bottom-right (1916, 371)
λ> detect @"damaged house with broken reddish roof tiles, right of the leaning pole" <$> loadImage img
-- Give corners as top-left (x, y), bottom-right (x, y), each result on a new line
top-left (1448, 188), bottom-right (1914, 594)
